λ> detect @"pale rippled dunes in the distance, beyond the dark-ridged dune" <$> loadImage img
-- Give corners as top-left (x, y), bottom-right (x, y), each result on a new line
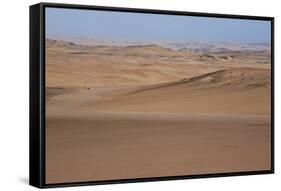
top-left (46, 41), bottom-right (270, 87)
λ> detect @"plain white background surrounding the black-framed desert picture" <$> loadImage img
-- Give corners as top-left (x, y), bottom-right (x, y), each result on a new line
top-left (0, 0), bottom-right (276, 191)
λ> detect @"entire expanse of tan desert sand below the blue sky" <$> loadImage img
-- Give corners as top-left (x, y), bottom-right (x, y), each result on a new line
top-left (46, 40), bottom-right (271, 183)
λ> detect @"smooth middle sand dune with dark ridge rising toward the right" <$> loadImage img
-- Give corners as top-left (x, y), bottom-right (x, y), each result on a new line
top-left (47, 68), bottom-right (271, 115)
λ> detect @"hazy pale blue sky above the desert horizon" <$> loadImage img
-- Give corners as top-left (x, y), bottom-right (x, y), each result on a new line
top-left (46, 8), bottom-right (271, 43)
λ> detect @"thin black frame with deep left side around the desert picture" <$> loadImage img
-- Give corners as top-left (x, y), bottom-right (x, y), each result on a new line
top-left (29, 3), bottom-right (274, 188)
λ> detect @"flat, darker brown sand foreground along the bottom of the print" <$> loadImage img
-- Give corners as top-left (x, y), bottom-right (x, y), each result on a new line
top-left (46, 114), bottom-right (271, 183)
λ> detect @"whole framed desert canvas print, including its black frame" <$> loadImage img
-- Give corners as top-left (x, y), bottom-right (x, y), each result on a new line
top-left (30, 3), bottom-right (274, 188)
